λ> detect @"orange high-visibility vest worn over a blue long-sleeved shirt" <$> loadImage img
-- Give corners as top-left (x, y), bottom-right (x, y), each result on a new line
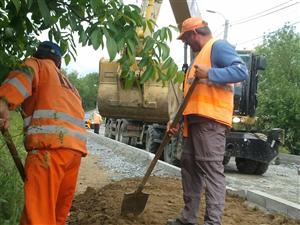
top-left (183, 39), bottom-right (234, 137)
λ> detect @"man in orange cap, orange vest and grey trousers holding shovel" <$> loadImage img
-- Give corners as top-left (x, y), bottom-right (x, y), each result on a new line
top-left (167, 17), bottom-right (248, 225)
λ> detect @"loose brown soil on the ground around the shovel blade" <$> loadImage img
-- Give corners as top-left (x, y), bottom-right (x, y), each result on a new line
top-left (68, 177), bottom-right (300, 225)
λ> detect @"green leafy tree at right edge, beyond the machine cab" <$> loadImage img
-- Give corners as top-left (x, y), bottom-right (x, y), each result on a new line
top-left (257, 25), bottom-right (300, 154)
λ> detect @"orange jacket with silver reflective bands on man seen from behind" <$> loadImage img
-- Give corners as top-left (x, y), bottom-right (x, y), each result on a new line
top-left (0, 58), bottom-right (87, 155)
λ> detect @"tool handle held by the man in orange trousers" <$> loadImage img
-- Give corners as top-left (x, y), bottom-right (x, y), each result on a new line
top-left (1, 129), bottom-right (26, 182)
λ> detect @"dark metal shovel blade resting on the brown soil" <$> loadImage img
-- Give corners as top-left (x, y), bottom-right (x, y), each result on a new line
top-left (121, 192), bottom-right (149, 216)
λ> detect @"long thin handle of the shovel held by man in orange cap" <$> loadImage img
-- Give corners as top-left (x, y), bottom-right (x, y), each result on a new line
top-left (136, 77), bottom-right (199, 193)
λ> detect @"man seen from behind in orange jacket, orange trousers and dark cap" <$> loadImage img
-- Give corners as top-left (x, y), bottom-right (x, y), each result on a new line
top-left (0, 41), bottom-right (87, 225)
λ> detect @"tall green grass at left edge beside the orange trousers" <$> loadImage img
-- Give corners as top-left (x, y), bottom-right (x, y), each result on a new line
top-left (0, 112), bottom-right (26, 225)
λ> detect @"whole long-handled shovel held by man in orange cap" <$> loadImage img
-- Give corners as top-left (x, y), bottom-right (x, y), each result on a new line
top-left (121, 78), bottom-right (199, 216)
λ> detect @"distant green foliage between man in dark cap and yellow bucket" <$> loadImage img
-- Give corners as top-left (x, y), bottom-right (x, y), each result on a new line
top-left (68, 72), bottom-right (99, 111)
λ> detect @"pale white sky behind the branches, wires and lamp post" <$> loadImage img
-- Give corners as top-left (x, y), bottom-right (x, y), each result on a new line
top-left (66, 0), bottom-right (300, 76)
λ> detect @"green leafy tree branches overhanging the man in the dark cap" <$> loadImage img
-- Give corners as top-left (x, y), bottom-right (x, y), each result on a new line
top-left (0, 0), bottom-right (183, 86)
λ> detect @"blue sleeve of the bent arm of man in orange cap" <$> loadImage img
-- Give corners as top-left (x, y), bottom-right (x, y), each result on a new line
top-left (208, 40), bottom-right (248, 83)
